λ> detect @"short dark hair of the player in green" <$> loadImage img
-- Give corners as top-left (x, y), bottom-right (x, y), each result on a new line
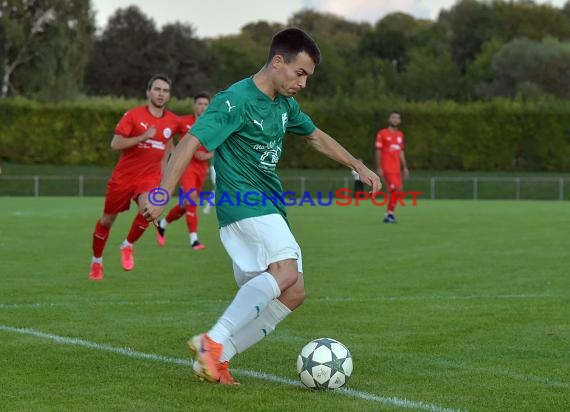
top-left (265, 28), bottom-right (321, 65)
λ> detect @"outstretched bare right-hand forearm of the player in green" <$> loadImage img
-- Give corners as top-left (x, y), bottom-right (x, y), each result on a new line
top-left (306, 128), bottom-right (382, 192)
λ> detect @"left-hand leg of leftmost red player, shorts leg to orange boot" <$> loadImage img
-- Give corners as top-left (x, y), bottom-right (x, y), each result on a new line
top-left (89, 180), bottom-right (130, 280)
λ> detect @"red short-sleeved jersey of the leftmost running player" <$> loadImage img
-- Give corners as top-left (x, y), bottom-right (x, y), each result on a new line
top-left (112, 106), bottom-right (181, 180)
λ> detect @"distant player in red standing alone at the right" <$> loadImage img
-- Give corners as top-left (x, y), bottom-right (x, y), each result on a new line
top-left (376, 111), bottom-right (410, 223)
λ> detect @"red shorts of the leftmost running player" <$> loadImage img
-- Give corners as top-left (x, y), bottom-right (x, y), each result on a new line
top-left (103, 176), bottom-right (160, 215)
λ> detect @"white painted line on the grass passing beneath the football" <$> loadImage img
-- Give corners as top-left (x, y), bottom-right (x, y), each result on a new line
top-left (0, 325), bottom-right (461, 412)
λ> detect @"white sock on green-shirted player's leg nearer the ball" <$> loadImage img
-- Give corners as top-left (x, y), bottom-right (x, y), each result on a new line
top-left (220, 299), bottom-right (291, 362)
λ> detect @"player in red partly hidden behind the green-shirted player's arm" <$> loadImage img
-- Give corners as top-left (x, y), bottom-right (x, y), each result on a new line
top-left (156, 93), bottom-right (214, 250)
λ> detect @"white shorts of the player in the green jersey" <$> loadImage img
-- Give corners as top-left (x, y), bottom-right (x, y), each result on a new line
top-left (220, 213), bottom-right (303, 286)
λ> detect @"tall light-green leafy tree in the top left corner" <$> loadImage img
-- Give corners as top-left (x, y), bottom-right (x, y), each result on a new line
top-left (0, 0), bottom-right (95, 99)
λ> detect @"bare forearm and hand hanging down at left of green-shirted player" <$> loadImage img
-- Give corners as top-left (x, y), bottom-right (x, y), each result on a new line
top-left (143, 134), bottom-right (200, 221)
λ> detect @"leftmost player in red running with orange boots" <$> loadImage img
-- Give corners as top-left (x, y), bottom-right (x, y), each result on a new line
top-left (89, 74), bottom-right (181, 280)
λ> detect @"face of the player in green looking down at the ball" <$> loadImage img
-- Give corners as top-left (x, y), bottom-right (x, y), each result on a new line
top-left (274, 52), bottom-right (315, 97)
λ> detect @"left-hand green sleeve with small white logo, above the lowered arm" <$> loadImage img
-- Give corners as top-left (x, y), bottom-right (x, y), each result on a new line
top-left (191, 92), bottom-right (244, 152)
